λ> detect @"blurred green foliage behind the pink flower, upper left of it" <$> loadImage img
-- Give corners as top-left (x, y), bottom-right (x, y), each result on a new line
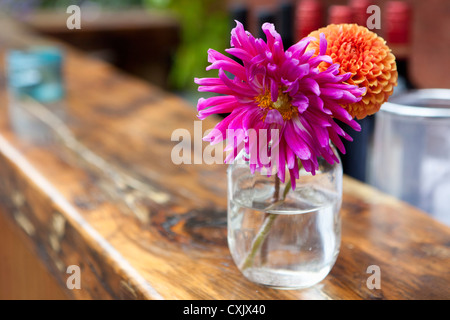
top-left (144, 0), bottom-right (230, 90)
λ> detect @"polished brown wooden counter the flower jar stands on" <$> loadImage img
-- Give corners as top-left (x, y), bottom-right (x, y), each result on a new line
top-left (0, 22), bottom-right (450, 300)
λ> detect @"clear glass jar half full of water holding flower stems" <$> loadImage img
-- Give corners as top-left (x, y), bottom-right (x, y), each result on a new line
top-left (227, 150), bottom-right (342, 289)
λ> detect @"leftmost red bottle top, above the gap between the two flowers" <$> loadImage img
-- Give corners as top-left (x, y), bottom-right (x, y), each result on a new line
top-left (294, 0), bottom-right (324, 41)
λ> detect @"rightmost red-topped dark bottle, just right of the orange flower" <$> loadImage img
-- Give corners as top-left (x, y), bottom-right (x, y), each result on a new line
top-left (385, 1), bottom-right (415, 92)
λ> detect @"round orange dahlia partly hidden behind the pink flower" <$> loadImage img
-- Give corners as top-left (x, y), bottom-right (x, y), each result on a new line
top-left (309, 24), bottom-right (398, 119)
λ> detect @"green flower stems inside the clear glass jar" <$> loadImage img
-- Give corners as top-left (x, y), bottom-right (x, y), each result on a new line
top-left (241, 176), bottom-right (291, 271)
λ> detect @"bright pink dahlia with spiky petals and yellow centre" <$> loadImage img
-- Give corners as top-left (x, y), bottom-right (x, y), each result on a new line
top-left (195, 22), bottom-right (365, 188)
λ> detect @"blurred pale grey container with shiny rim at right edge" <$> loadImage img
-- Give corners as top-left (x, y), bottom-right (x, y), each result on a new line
top-left (369, 89), bottom-right (450, 225)
